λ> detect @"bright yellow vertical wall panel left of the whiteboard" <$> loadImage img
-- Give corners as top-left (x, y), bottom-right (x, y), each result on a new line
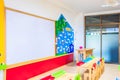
top-left (0, 0), bottom-right (5, 63)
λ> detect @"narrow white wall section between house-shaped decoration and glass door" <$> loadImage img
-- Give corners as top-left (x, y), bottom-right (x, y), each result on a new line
top-left (74, 13), bottom-right (84, 60)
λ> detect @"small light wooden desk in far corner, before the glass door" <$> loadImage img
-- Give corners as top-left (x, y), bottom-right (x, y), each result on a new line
top-left (76, 48), bottom-right (93, 61)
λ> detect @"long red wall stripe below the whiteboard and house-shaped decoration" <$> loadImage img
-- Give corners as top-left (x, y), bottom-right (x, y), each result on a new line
top-left (6, 54), bottom-right (73, 80)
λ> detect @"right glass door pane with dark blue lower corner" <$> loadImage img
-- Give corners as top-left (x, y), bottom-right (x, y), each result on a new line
top-left (102, 25), bottom-right (119, 63)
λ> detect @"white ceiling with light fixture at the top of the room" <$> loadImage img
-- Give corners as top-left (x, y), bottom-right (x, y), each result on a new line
top-left (48, 0), bottom-right (120, 13)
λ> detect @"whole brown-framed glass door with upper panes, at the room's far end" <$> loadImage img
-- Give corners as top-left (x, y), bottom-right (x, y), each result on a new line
top-left (85, 14), bottom-right (120, 63)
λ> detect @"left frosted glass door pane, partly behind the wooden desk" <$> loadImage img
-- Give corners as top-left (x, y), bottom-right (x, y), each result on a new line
top-left (86, 26), bottom-right (100, 57)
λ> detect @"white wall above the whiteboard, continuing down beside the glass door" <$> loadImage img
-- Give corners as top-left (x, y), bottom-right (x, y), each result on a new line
top-left (0, 0), bottom-right (84, 80)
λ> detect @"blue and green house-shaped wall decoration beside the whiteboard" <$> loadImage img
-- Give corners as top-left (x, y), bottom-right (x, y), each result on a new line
top-left (55, 14), bottom-right (74, 55)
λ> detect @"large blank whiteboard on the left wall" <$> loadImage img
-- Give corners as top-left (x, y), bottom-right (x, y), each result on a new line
top-left (6, 10), bottom-right (55, 64)
